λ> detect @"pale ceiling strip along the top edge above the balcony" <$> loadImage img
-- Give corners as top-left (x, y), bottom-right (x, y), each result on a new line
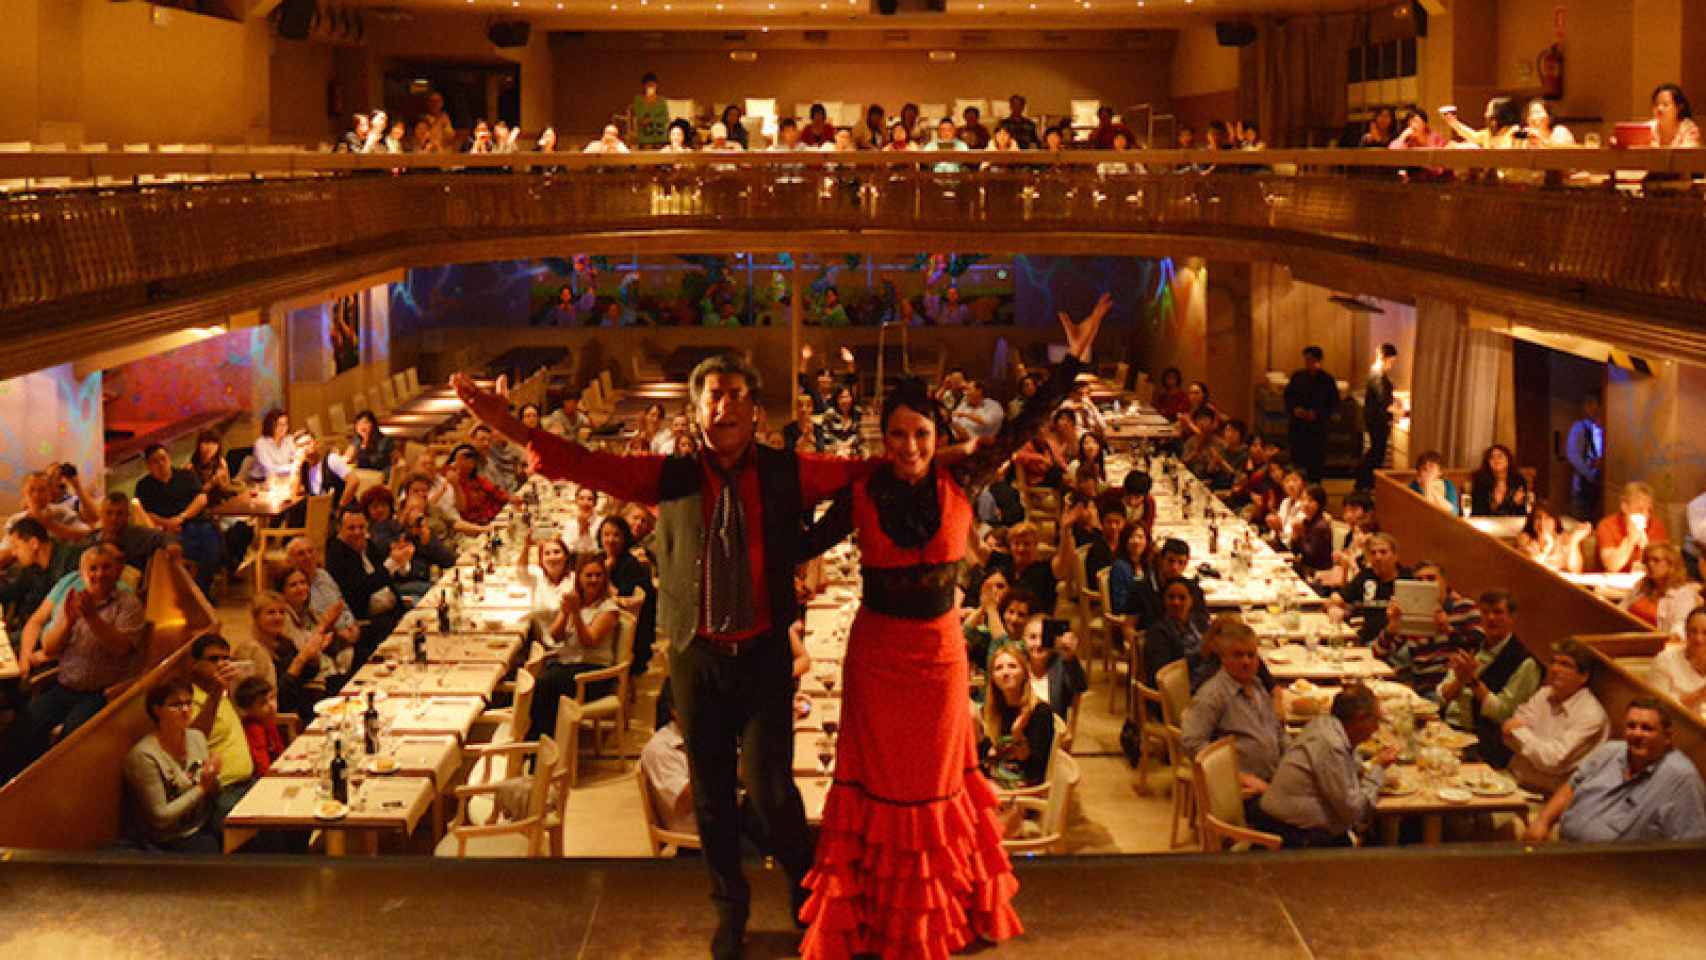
top-left (353, 0), bottom-right (1392, 31)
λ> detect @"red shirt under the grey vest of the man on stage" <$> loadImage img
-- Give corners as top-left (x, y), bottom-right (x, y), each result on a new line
top-left (527, 430), bottom-right (882, 639)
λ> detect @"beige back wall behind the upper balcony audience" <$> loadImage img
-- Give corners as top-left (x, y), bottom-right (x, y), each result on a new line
top-left (545, 46), bottom-right (1169, 136)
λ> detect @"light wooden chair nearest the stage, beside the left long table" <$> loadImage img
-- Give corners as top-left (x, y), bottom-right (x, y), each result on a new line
top-left (433, 737), bottom-right (558, 859)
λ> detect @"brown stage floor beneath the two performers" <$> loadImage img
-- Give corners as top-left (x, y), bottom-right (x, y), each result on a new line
top-left (0, 847), bottom-right (1706, 960)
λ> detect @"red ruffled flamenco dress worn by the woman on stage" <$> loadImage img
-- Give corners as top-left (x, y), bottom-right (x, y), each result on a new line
top-left (800, 471), bottom-right (1024, 960)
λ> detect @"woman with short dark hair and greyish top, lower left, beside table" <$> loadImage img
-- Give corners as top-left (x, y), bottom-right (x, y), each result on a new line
top-left (125, 677), bottom-right (222, 854)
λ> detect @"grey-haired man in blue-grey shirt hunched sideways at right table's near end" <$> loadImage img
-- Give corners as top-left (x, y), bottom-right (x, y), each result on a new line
top-left (1256, 685), bottom-right (1397, 847)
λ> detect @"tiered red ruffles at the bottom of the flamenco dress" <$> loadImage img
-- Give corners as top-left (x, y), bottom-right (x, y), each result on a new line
top-left (800, 769), bottom-right (1024, 960)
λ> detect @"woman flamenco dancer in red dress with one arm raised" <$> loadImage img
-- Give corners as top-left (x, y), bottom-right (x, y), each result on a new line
top-left (800, 295), bottom-right (1112, 960)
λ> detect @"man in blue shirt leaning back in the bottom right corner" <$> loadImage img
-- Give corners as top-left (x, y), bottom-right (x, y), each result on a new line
top-left (1525, 697), bottom-right (1706, 842)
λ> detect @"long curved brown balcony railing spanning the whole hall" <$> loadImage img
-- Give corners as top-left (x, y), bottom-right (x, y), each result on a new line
top-left (0, 150), bottom-right (1706, 333)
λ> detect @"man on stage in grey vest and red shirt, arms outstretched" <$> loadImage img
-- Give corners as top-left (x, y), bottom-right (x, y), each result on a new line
top-left (452, 355), bottom-right (880, 958)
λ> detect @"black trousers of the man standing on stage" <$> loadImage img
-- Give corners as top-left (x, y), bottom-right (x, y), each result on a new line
top-left (669, 627), bottom-right (812, 921)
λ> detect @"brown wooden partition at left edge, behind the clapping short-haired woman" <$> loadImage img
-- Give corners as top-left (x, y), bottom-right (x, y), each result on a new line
top-left (0, 554), bottom-right (218, 849)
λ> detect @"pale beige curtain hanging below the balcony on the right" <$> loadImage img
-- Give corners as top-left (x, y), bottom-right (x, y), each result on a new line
top-left (1409, 297), bottom-right (1515, 467)
